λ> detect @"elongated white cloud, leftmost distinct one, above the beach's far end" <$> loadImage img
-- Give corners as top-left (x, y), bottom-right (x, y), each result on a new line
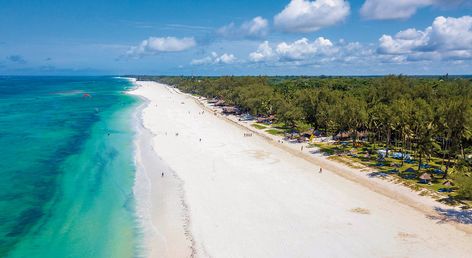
top-left (127, 37), bottom-right (197, 57)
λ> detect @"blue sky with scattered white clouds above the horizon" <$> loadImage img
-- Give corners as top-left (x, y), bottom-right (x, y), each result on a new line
top-left (0, 0), bottom-right (472, 75)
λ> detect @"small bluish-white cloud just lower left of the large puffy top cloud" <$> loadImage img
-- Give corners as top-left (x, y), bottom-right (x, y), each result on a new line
top-left (217, 16), bottom-right (269, 38)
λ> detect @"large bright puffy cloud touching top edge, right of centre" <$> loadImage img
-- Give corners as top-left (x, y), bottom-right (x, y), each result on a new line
top-left (274, 0), bottom-right (350, 32)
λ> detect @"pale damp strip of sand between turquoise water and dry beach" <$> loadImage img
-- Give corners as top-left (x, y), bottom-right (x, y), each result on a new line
top-left (128, 84), bottom-right (193, 257)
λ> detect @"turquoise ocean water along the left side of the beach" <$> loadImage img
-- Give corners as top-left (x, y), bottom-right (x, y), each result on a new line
top-left (0, 77), bottom-right (140, 258)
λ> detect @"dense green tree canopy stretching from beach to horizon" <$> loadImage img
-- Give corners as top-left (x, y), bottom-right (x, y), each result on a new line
top-left (138, 76), bottom-right (472, 198)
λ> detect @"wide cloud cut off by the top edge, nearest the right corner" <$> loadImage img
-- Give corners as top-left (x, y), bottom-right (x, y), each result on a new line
top-left (360, 0), bottom-right (468, 20)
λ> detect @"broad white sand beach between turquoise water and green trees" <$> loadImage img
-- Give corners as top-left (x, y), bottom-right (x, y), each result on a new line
top-left (131, 82), bottom-right (472, 258)
